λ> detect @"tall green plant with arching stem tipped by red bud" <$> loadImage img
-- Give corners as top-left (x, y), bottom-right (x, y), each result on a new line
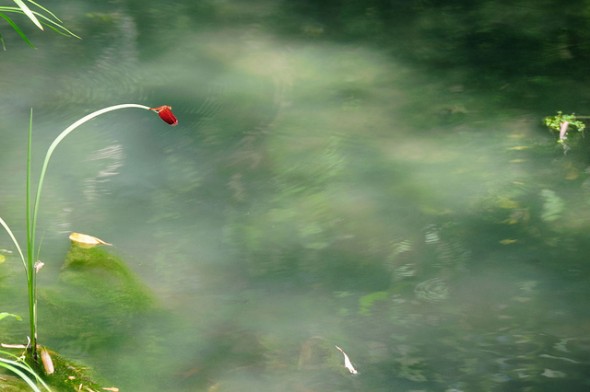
top-left (0, 104), bottom-right (178, 362)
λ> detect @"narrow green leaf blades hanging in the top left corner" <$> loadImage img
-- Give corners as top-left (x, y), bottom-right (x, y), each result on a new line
top-left (0, 0), bottom-right (80, 50)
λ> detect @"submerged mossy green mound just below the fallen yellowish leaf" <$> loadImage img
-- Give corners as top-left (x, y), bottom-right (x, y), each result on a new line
top-left (39, 245), bottom-right (156, 362)
